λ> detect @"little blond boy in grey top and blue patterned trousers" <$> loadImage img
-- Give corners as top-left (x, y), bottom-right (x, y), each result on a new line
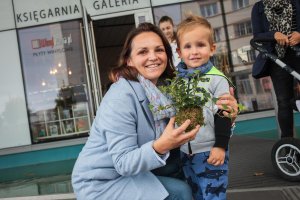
top-left (177, 15), bottom-right (231, 200)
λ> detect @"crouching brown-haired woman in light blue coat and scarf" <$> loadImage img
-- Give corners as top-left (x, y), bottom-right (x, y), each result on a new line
top-left (72, 23), bottom-right (237, 200)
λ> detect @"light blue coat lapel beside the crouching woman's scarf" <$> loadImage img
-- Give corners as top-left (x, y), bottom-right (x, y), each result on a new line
top-left (128, 81), bottom-right (155, 133)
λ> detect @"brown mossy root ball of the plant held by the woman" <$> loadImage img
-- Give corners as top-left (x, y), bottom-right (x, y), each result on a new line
top-left (175, 107), bottom-right (204, 132)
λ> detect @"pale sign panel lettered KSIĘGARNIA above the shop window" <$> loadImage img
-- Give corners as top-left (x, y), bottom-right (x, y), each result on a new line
top-left (14, 0), bottom-right (82, 28)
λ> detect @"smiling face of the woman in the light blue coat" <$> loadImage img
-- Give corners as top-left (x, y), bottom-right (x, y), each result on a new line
top-left (127, 32), bottom-right (168, 84)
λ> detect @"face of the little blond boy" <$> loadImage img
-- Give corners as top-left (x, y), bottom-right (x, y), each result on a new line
top-left (177, 26), bottom-right (216, 68)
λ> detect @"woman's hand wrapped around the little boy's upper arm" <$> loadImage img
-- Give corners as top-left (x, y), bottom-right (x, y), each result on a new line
top-left (216, 87), bottom-right (238, 121)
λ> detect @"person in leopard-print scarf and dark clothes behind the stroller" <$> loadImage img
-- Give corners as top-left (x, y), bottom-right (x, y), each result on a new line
top-left (251, 0), bottom-right (300, 138)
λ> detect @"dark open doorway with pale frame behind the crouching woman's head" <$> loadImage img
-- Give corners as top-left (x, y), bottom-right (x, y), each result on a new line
top-left (89, 9), bottom-right (153, 95)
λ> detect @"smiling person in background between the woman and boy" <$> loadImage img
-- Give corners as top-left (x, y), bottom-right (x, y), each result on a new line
top-left (158, 16), bottom-right (180, 68)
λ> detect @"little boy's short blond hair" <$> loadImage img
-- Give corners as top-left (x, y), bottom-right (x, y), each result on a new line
top-left (176, 14), bottom-right (214, 47)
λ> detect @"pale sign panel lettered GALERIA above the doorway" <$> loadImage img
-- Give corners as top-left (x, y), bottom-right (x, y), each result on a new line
top-left (82, 0), bottom-right (150, 16)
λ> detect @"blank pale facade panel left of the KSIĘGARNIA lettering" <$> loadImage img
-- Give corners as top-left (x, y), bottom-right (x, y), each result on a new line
top-left (0, 0), bottom-right (15, 31)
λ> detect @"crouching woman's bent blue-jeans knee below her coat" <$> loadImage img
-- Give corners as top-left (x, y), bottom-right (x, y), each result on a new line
top-left (156, 176), bottom-right (192, 200)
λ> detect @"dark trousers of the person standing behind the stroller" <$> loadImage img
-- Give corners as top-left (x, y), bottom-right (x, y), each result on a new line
top-left (270, 48), bottom-right (300, 137)
